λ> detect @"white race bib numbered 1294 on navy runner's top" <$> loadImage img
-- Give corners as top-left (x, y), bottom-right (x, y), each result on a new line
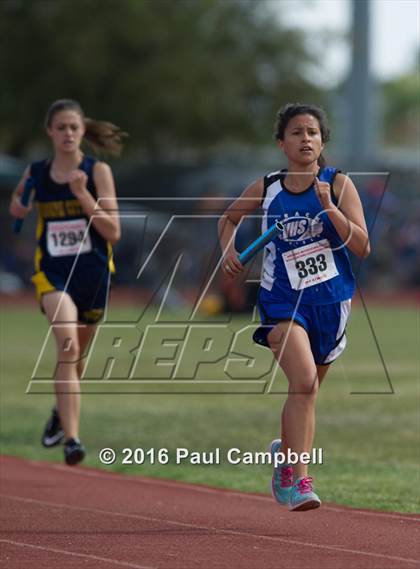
top-left (47, 218), bottom-right (92, 257)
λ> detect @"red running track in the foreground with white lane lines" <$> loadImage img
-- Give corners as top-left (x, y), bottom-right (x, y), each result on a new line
top-left (0, 457), bottom-right (420, 569)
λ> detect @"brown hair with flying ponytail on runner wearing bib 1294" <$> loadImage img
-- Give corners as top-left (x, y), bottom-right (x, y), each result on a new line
top-left (45, 99), bottom-right (128, 156)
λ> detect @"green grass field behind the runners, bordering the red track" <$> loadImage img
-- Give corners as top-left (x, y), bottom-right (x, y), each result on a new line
top-left (1, 306), bottom-right (420, 512)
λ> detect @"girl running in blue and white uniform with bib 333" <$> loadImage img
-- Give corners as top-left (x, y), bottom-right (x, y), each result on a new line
top-left (219, 104), bottom-right (370, 511)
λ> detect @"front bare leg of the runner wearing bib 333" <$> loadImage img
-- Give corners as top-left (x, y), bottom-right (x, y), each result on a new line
top-left (268, 322), bottom-right (325, 479)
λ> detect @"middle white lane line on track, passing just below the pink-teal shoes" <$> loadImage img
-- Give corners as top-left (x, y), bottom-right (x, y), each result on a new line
top-left (0, 494), bottom-right (420, 567)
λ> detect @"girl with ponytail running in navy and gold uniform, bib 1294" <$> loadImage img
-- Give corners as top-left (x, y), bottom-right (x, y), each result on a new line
top-left (10, 99), bottom-right (124, 465)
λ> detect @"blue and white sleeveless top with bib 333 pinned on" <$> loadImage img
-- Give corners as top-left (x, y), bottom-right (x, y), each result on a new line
top-left (261, 168), bottom-right (355, 305)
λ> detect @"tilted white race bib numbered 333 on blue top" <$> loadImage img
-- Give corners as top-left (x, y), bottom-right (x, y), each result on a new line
top-left (282, 239), bottom-right (338, 290)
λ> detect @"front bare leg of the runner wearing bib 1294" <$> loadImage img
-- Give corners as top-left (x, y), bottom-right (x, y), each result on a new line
top-left (42, 291), bottom-right (80, 439)
